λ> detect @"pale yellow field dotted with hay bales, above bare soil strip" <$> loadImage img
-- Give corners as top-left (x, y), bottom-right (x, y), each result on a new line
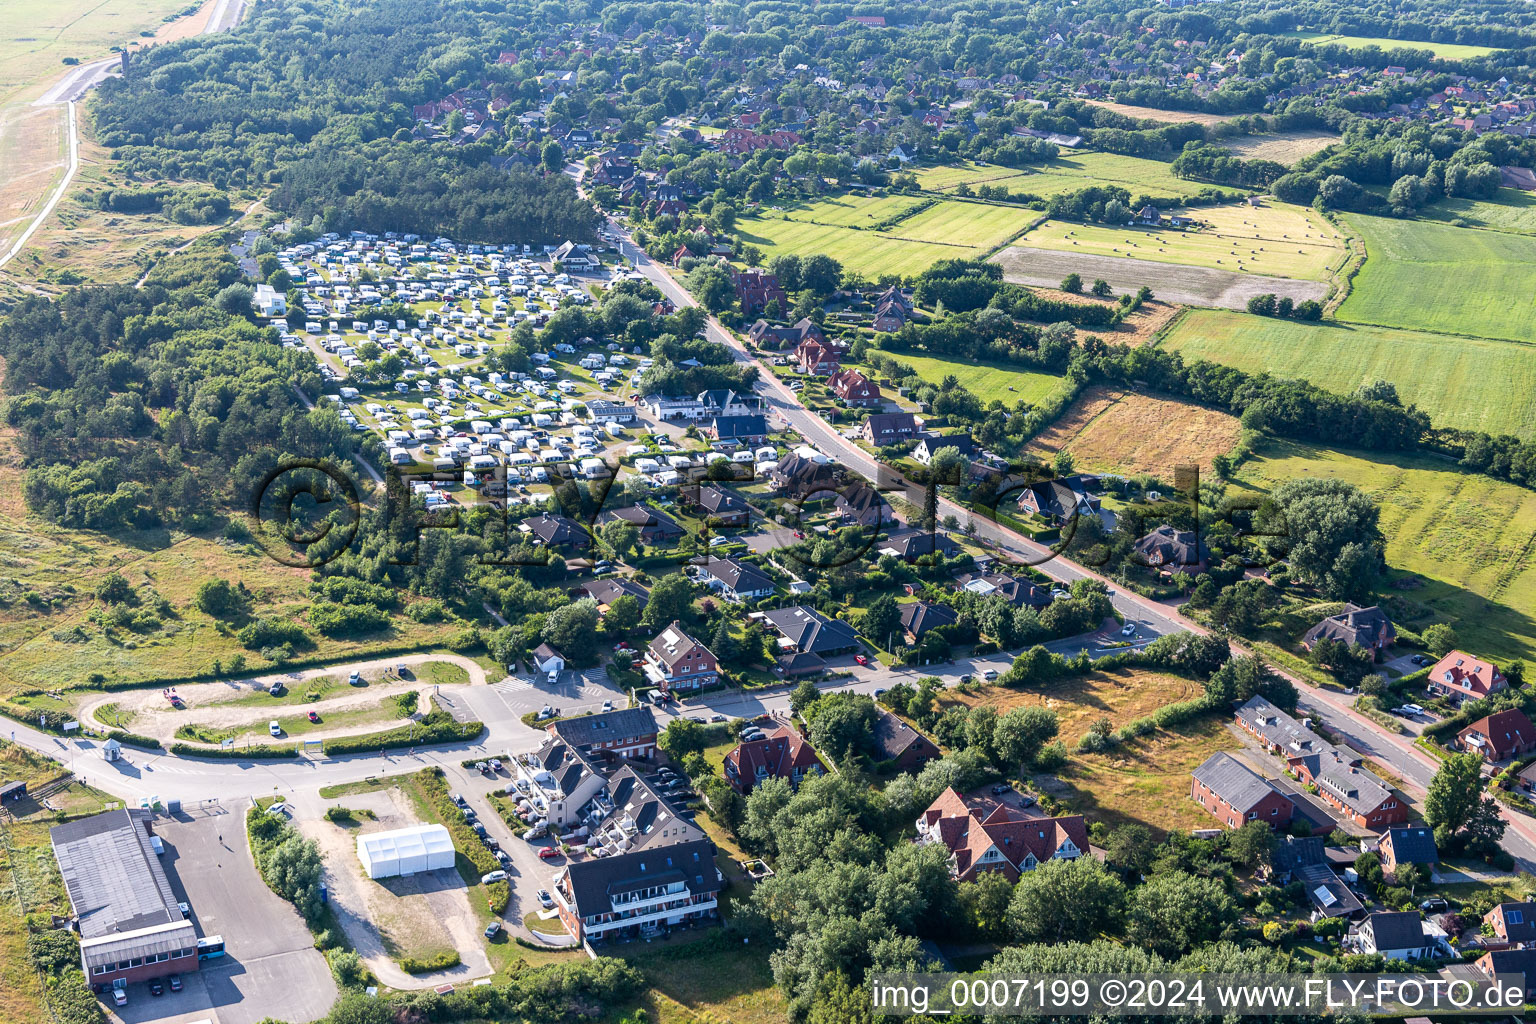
top-left (1021, 203), bottom-right (1346, 281)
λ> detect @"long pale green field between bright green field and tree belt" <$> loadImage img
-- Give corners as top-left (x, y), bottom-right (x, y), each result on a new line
top-left (1161, 307), bottom-right (1536, 438)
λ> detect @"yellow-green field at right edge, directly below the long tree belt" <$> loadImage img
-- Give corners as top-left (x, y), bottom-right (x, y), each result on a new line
top-left (1227, 442), bottom-right (1536, 660)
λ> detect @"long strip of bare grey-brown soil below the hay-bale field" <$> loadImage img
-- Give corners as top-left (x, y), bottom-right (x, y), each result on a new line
top-left (994, 246), bottom-right (1329, 309)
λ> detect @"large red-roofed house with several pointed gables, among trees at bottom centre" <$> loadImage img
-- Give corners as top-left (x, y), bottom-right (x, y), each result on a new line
top-left (917, 789), bottom-right (1089, 881)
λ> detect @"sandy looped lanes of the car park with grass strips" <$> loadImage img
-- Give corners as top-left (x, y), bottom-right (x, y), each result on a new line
top-left (80, 654), bottom-right (487, 742)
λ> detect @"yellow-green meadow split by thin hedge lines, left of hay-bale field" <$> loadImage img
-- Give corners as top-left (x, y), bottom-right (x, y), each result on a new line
top-left (739, 197), bottom-right (1038, 276)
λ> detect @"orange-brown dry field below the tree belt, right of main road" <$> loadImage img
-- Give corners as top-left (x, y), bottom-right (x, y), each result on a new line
top-left (1029, 385), bottom-right (1243, 479)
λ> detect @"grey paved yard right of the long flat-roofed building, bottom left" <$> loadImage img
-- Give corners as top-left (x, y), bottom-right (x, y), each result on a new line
top-left (154, 800), bottom-right (336, 1024)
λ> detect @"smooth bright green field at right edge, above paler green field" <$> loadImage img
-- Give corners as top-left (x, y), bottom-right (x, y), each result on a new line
top-left (1338, 213), bottom-right (1536, 340)
